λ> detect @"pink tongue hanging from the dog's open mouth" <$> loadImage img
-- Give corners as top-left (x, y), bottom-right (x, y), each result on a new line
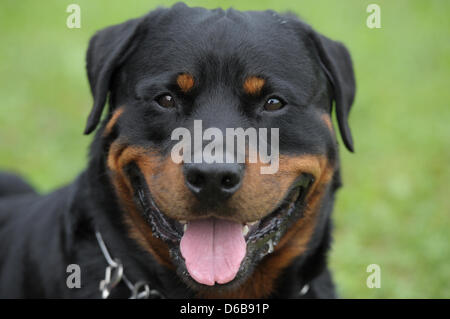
top-left (180, 218), bottom-right (247, 286)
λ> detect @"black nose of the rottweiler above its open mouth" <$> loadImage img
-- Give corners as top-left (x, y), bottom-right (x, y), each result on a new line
top-left (184, 163), bottom-right (244, 203)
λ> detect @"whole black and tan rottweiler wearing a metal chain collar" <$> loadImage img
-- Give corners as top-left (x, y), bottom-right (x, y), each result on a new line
top-left (0, 4), bottom-right (355, 298)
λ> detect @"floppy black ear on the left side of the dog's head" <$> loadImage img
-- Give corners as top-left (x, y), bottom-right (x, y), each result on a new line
top-left (84, 18), bottom-right (143, 134)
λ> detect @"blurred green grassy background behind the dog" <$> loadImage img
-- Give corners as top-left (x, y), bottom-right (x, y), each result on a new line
top-left (0, 0), bottom-right (450, 298)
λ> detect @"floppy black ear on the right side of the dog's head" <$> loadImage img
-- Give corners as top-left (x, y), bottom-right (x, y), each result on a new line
top-left (310, 29), bottom-right (356, 152)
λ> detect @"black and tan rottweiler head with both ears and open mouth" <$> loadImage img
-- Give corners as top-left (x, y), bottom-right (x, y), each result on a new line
top-left (85, 4), bottom-right (355, 296)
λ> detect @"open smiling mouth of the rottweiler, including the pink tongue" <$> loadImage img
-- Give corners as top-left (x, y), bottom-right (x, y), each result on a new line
top-left (127, 165), bottom-right (314, 290)
